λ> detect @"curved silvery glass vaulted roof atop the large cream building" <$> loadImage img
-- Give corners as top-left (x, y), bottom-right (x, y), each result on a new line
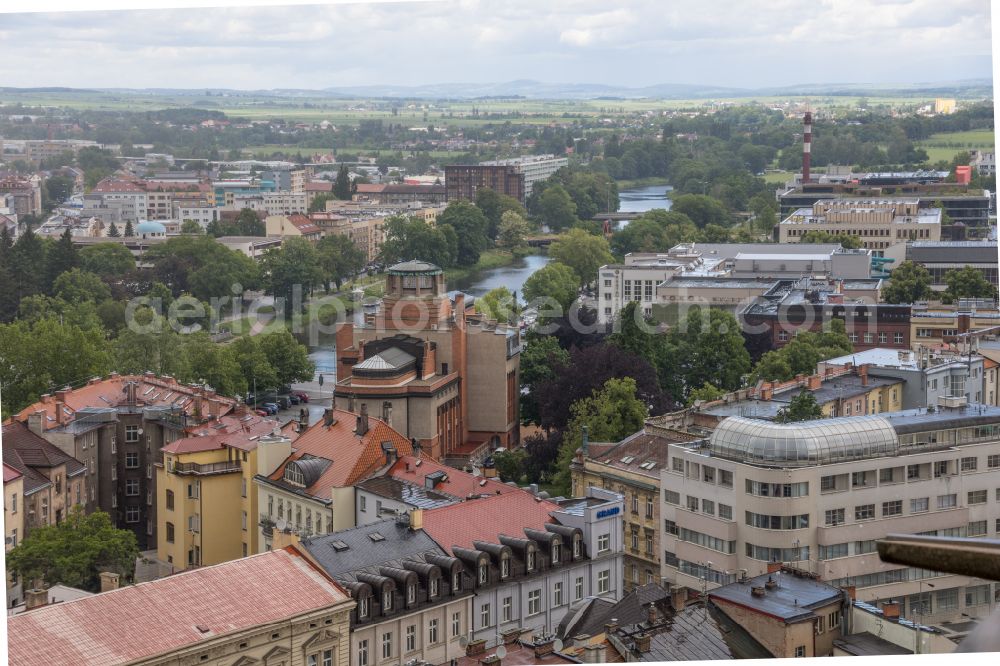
top-left (709, 416), bottom-right (898, 467)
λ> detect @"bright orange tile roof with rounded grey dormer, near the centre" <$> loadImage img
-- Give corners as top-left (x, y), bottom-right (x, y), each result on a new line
top-left (269, 409), bottom-right (413, 499)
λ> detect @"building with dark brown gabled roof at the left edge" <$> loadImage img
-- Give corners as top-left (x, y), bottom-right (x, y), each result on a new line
top-left (3, 421), bottom-right (92, 540)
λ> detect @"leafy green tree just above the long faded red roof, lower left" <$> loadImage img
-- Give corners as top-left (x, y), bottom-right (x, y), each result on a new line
top-left (7, 505), bottom-right (139, 592)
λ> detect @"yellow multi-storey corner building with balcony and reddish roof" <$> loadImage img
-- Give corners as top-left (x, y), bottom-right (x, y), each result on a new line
top-left (156, 414), bottom-right (295, 571)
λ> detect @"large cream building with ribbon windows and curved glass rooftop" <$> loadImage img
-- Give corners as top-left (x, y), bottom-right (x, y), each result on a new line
top-left (661, 403), bottom-right (1000, 622)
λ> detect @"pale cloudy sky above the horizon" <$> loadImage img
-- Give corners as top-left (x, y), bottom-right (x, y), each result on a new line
top-left (0, 0), bottom-right (992, 89)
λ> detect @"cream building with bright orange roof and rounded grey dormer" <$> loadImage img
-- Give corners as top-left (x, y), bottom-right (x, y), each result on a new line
top-left (253, 405), bottom-right (413, 550)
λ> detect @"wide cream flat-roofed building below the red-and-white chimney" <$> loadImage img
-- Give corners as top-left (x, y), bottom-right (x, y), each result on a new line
top-left (778, 199), bottom-right (941, 256)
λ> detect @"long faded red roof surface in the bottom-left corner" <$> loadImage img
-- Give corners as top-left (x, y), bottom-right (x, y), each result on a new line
top-left (7, 548), bottom-right (348, 666)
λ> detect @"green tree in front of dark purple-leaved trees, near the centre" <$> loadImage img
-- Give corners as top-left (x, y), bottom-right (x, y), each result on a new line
top-left (553, 377), bottom-right (649, 496)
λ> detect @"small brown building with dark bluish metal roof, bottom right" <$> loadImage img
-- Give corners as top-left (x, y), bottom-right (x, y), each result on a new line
top-left (708, 565), bottom-right (849, 658)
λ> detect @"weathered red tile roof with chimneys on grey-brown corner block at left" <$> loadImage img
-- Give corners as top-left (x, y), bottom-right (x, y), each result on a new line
top-left (14, 373), bottom-right (236, 430)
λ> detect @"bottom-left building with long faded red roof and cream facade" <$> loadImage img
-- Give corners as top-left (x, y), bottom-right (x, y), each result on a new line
top-left (7, 548), bottom-right (355, 666)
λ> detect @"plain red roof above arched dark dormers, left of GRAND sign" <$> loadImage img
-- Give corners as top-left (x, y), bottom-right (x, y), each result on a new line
top-left (424, 490), bottom-right (560, 553)
